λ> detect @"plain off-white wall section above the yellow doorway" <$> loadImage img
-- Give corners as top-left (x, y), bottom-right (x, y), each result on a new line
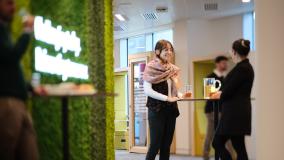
top-left (188, 16), bottom-right (243, 56)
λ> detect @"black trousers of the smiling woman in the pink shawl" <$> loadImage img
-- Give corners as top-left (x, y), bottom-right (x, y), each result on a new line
top-left (146, 106), bottom-right (176, 160)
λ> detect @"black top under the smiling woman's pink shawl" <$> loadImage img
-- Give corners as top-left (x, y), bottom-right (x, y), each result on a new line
top-left (146, 81), bottom-right (179, 117)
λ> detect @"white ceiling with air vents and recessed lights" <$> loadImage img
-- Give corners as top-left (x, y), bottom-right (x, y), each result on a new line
top-left (114, 0), bottom-right (254, 36)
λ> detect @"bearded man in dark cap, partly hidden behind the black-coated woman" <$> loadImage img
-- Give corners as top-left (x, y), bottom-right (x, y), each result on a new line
top-left (203, 55), bottom-right (236, 160)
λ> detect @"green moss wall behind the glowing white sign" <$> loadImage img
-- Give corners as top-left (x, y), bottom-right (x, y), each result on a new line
top-left (13, 0), bottom-right (114, 160)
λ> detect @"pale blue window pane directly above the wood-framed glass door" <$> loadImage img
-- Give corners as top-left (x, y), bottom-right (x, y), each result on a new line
top-left (128, 35), bottom-right (146, 54)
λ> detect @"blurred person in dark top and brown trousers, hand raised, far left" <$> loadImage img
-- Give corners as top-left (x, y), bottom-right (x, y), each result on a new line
top-left (0, 0), bottom-right (38, 160)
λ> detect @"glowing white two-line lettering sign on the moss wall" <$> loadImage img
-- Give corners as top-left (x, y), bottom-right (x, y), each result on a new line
top-left (34, 16), bottom-right (89, 80)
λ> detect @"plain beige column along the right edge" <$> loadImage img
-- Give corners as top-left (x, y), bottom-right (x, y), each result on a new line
top-left (255, 0), bottom-right (284, 160)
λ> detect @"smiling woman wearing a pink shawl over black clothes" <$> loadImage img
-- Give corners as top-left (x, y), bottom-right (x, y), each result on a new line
top-left (143, 40), bottom-right (180, 160)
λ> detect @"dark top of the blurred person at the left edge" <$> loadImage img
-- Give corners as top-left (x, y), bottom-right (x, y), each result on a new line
top-left (0, 23), bottom-right (30, 100)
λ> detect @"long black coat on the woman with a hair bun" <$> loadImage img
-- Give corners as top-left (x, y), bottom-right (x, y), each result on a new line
top-left (217, 59), bottom-right (254, 135)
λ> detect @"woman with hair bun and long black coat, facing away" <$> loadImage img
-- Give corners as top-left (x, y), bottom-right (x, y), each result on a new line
top-left (213, 39), bottom-right (254, 160)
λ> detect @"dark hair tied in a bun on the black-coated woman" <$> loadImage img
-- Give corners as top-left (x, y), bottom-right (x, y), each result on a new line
top-left (232, 39), bottom-right (250, 57)
